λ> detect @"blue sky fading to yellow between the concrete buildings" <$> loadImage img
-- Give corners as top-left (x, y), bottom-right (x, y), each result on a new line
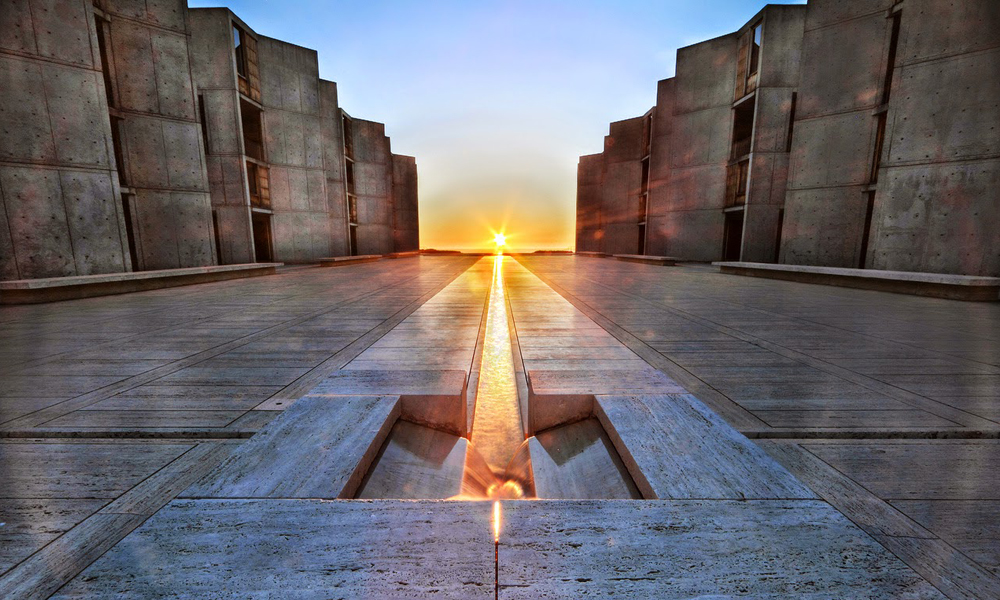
top-left (191, 0), bottom-right (801, 248)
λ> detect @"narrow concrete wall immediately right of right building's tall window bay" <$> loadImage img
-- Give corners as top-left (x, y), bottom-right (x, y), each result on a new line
top-left (740, 5), bottom-right (806, 262)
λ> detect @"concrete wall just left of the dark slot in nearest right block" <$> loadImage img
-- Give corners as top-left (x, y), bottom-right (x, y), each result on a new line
top-left (780, 0), bottom-right (891, 267)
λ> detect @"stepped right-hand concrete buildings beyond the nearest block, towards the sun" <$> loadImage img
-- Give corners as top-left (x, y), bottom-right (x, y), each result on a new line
top-left (578, 5), bottom-right (805, 261)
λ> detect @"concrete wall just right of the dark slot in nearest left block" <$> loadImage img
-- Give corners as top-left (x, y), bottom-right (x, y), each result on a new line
top-left (104, 0), bottom-right (216, 270)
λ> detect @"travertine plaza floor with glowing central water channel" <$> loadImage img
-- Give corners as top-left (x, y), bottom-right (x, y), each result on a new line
top-left (0, 255), bottom-right (1000, 599)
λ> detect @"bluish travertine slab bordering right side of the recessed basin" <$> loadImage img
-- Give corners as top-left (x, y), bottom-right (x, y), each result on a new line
top-left (594, 394), bottom-right (816, 500)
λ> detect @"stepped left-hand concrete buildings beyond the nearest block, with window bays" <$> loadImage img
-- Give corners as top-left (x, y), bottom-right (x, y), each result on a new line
top-left (190, 8), bottom-right (419, 262)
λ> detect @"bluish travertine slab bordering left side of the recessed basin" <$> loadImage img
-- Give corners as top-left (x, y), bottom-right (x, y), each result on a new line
top-left (181, 396), bottom-right (400, 498)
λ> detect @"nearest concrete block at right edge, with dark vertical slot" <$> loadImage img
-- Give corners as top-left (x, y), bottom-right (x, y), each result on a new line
top-left (781, 0), bottom-right (1000, 276)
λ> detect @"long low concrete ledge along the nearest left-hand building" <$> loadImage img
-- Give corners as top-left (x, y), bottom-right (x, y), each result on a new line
top-left (0, 263), bottom-right (282, 304)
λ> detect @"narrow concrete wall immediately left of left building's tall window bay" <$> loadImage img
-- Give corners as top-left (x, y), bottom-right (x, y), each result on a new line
top-left (189, 8), bottom-right (254, 264)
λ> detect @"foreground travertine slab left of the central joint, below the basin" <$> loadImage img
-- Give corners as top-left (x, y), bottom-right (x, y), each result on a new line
top-left (53, 500), bottom-right (494, 600)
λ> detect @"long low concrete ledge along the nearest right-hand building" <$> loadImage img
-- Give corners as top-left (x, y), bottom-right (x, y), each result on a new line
top-left (712, 262), bottom-right (1000, 302)
